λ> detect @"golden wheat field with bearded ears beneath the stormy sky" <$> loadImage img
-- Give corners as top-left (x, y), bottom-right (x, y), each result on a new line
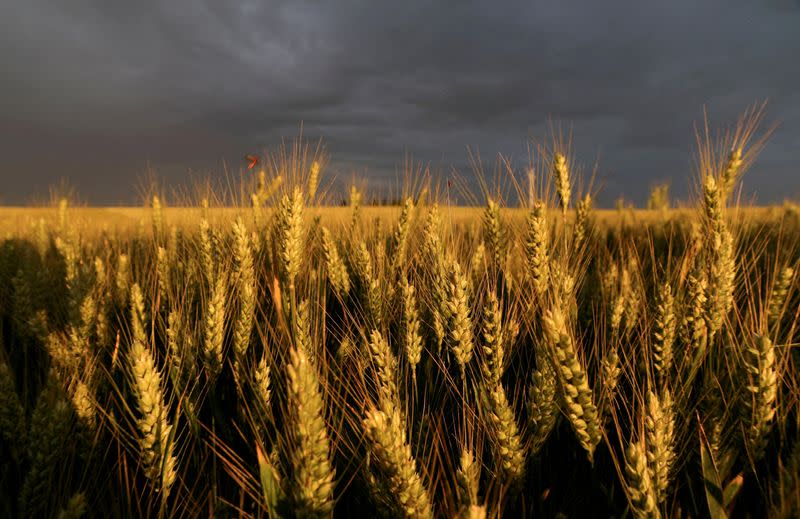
top-left (0, 116), bottom-right (800, 519)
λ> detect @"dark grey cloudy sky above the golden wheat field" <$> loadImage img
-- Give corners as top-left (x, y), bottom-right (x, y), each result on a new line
top-left (0, 0), bottom-right (800, 205)
